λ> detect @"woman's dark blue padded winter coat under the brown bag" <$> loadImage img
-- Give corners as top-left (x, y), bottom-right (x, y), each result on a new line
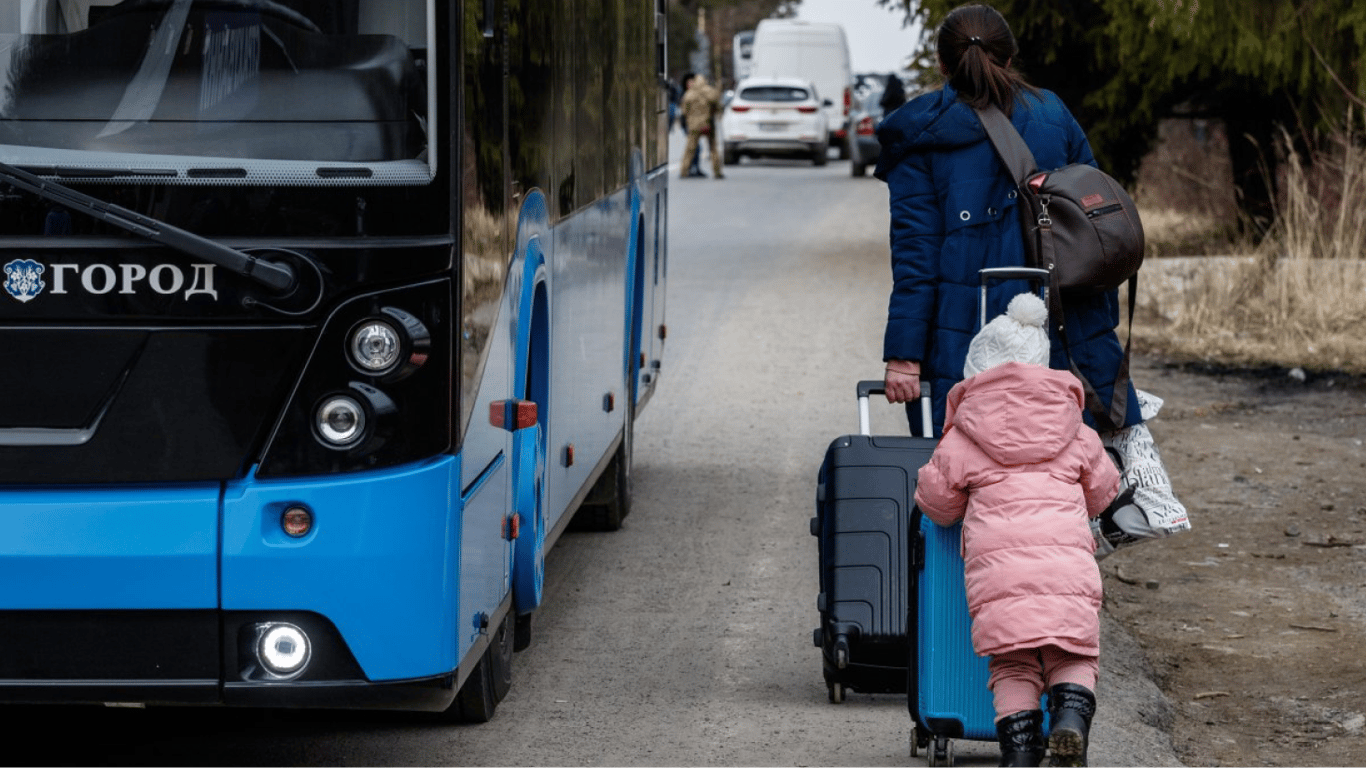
top-left (874, 85), bottom-right (1142, 435)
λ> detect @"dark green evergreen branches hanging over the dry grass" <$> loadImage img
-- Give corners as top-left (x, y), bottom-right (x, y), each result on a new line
top-left (872, 0), bottom-right (1366, 224)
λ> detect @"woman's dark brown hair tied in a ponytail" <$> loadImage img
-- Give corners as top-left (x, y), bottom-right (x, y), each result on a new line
top-left (937, 4), bottom-right (1038, 115)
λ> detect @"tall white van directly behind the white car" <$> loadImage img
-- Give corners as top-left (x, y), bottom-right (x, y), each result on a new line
top-left (750, 19), bottom-right (854, 159)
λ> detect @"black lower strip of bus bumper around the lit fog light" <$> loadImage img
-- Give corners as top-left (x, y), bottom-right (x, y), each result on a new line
top-left (0, 611), bottom-right (456, 712)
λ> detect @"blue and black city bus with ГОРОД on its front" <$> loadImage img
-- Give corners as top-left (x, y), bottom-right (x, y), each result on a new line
top-left (0, 0), bottom-right (668, 722)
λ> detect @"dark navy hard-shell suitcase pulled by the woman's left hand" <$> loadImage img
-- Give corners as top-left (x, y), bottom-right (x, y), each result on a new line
top-left (811, 381), bottom-right (937, 704)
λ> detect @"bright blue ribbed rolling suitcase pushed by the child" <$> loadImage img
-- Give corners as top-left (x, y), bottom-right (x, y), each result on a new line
top-left (906, 268), bottom-right (1048, 768)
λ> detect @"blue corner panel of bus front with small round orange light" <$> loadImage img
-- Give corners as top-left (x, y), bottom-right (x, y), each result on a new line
top-left (223, 456), bottom-right (463, 681)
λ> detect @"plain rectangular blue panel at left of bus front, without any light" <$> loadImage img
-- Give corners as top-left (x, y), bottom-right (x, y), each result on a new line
top-left (0, 485), bottom-right (219, 609)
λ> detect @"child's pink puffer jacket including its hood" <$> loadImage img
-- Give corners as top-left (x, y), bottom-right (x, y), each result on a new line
top-left (915, 362), bottom-right (1119, 656)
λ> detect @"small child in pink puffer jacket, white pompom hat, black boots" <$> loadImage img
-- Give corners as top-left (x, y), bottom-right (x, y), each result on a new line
top-left (915, 294), bottom-right (1120, 768)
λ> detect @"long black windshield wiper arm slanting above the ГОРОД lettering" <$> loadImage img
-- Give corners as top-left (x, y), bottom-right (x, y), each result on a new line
top-left (0, 163), bottom-right (296, 292)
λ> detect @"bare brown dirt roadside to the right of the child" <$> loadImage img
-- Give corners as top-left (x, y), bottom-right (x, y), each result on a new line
top-left (1102, 359), bottom-right (1366, 768)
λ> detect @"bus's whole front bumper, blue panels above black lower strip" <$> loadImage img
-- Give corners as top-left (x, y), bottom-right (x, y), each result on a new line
top-left (0, 456), bottom-right (477, 709)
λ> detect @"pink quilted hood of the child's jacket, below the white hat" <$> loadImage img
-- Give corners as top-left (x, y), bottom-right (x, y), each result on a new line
top-left (945, 362), bottom-right (1086, 466)
